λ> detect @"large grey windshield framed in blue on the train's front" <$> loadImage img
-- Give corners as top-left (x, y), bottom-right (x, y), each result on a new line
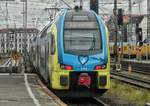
top-left (64, 10), bottom-right (102, 55)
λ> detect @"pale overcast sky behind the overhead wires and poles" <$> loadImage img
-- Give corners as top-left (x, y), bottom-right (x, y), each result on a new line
top-left (0, 0), bottom-right (147, 29)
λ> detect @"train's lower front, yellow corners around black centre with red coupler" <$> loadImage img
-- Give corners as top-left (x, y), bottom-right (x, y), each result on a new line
top-left (51, 71), bottom-right (110, 97)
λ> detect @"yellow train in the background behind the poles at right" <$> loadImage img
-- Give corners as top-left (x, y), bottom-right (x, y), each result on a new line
top-left (109, 39), bottom-right (150, 59)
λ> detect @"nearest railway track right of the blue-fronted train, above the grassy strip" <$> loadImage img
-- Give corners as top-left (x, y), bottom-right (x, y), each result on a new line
top-left (111, 71), bottom-right (150, 89)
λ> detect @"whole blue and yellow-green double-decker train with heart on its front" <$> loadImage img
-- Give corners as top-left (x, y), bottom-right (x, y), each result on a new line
top-left (30, 9), bottom-right (110, 97)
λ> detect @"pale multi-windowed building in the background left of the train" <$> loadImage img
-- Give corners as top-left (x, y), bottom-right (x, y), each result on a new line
top-left (0, 28), bottom-right (39, 54)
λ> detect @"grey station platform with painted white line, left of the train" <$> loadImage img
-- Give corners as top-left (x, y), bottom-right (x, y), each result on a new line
top-left (0, 74), bottom-right (64, 106)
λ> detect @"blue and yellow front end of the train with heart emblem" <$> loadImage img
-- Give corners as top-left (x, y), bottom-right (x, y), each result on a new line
top-left (52, 10), bottom-right (110, 96)
